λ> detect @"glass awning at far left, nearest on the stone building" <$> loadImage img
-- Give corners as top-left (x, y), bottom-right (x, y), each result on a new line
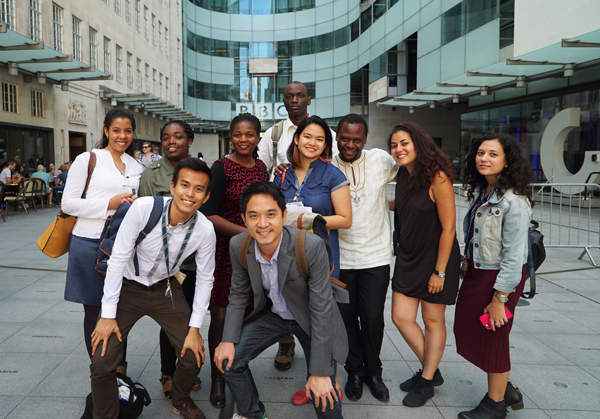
top-left (0, 23), bottom-right (112, 90)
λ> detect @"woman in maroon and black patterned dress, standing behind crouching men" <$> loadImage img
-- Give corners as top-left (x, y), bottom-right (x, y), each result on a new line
top-left (201, 113), bottom-right (269, 408)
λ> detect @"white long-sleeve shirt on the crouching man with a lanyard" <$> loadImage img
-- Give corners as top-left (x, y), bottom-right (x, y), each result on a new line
top-left (102, 199), bottom-right (217, 328)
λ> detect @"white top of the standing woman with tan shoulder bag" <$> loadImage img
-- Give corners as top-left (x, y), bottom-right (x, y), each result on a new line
top-left (62, 149), bottom-right (144, 239)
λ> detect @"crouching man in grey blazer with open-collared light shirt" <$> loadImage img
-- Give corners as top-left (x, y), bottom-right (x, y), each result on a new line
top-left (215, 182), bottom-right (348, 419)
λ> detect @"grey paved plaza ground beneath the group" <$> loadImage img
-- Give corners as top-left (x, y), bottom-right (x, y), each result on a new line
top-left (0, 208), bottom-right (600, 419)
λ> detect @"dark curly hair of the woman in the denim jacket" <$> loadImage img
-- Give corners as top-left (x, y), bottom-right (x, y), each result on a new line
top-left (463, 131), bottom-right (534, 201)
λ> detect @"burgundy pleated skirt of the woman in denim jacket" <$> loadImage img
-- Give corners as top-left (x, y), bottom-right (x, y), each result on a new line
top-left (454, 260), bottom-right (525, 373)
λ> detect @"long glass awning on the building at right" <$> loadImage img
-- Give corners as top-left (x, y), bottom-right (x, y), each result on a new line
top-left (377, 26), bottom-right (600, 107)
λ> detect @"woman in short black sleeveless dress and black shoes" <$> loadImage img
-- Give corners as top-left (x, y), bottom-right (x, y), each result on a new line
top-left (388, 122), bottom-right (460, 407)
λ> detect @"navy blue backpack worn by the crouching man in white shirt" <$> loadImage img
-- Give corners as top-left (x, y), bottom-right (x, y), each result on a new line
top-left (96, 196), bottom-right (164, 276)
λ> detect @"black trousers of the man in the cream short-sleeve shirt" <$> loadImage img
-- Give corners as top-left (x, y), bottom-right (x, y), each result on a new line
top-left (338, 265), bottom-right (390, 377)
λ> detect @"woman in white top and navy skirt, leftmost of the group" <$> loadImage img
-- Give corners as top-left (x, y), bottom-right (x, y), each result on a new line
top-left (62, 108), bottom-right (144, 365)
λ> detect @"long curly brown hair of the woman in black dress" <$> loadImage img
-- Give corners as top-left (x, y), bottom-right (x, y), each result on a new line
top-left (388, 122), bottom-right (454, 189)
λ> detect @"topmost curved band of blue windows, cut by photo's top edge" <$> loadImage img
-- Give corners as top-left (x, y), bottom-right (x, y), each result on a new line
top-left (189, 0), bottom-right (314, 15)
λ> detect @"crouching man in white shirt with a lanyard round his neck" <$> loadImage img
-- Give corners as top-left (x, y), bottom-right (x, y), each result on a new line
top-left (91, 158), bottom-right (216, 419)
